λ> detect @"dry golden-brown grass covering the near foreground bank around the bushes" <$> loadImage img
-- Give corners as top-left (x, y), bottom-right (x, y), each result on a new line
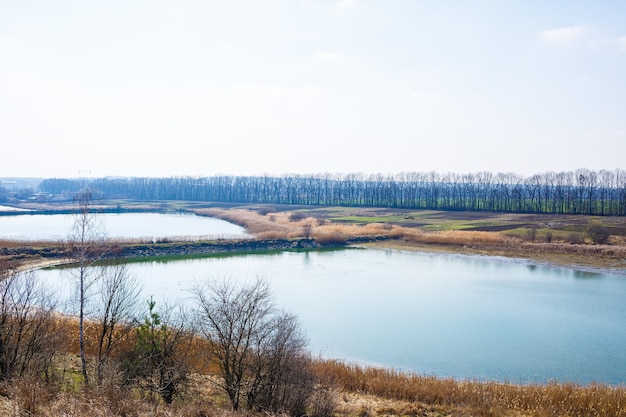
top-left (0, 290), bottom-right (626, 417)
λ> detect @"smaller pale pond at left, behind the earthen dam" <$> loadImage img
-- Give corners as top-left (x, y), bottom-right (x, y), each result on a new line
top-left (0, 213), bottom-right (247, 240)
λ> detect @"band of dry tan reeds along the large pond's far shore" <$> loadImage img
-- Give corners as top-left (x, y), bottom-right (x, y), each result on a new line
top-left (195, 208), bottom-right (626, 269)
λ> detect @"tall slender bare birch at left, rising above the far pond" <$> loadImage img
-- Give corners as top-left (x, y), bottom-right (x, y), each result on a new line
top-left (68, 188), bottom-right (106, 384)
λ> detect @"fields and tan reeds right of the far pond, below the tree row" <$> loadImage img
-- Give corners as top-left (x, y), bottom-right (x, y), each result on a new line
top-left (194, 202), bottom-right (626, 273)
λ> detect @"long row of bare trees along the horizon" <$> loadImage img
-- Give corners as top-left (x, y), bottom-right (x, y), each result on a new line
top-left (40, 169), bottom-right (626, 216)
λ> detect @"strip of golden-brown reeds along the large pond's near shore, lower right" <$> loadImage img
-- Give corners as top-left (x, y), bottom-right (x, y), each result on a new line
top-left (316, 360), bottom-right (626, 417)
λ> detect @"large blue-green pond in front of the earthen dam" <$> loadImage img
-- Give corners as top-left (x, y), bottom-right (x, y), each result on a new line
top-left (35, 245), bottom-right (626, 384)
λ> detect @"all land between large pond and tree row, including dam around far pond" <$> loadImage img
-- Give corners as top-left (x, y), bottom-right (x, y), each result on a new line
top-left (0, 201), bottom-right (626, 273)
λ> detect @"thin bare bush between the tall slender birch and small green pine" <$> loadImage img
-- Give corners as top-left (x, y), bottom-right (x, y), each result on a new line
top-left (96, 262), bottom-right (141, 384)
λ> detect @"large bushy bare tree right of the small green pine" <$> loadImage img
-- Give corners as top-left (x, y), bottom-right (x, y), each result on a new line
top-left (194, 279), bottom-right (313, 413)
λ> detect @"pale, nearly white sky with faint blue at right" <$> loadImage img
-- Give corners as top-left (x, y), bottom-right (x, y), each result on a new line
top-left (0, 0), bottom-right (626, 178)
